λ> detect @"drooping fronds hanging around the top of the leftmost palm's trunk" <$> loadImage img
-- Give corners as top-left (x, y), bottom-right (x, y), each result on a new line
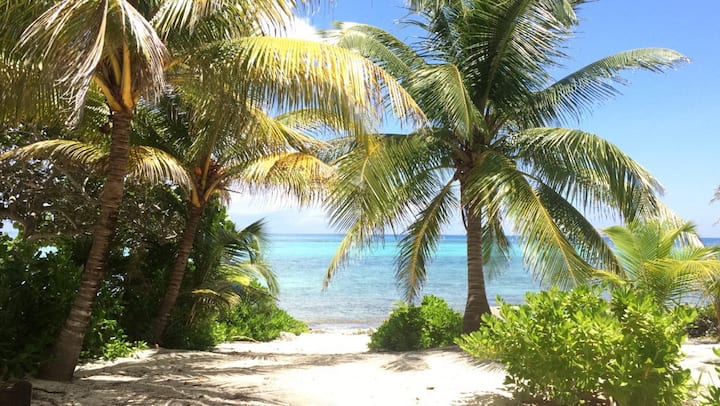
top-left (19, 0), bottom-right (166, 117)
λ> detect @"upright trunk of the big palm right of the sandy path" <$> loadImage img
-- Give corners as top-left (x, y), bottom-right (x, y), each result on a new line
top-left (463, 206), bottom-right (490, 333)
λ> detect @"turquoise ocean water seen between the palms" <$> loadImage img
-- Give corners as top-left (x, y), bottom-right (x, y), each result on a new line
top-left (265, 234), bottom-right (720, 329)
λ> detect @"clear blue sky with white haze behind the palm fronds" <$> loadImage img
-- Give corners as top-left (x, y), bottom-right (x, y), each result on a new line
top-left (230, 0), bottom-right (720, 237)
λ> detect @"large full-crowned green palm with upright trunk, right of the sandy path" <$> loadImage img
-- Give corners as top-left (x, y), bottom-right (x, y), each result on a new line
top-left (326, 0), bottom-right (686, 332)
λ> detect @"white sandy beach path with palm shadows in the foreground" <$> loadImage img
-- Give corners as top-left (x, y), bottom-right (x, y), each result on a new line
top-left (32, 331), bottom-right (720, 406)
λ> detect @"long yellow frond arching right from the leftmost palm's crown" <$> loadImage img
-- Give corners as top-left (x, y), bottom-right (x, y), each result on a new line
top-left (187, 37), bottom-right (424, 129)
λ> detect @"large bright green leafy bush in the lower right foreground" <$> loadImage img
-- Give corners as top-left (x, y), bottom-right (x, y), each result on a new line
top-left (458, 287), bottom-right (695, 406)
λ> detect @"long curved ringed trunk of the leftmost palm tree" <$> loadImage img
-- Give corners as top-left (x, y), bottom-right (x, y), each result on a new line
top-left (40, 111), bottom-right (132, 381)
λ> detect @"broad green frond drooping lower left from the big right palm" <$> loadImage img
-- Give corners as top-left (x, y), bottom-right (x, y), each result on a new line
top-left (325, 135), bottom-right (451, 285)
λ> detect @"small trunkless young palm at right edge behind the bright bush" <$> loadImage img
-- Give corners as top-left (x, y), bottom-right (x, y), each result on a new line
top-left (595, 221), bottom-right (720, 308)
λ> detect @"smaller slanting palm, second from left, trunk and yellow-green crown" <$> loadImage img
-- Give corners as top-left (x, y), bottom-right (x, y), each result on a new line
top-left (133, 95), bottom-right (346, 343)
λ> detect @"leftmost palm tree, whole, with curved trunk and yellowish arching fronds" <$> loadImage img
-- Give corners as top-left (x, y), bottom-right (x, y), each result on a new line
top-left (0, 0), bottom-right (422, 380)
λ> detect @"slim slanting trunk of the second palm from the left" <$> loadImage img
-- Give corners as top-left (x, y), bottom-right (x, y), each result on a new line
top-left (152, 203), bottom-right (205, 344)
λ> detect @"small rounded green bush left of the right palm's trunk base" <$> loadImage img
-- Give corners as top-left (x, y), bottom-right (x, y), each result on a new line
top-left (368, 296), bottom-right (462, 351)
